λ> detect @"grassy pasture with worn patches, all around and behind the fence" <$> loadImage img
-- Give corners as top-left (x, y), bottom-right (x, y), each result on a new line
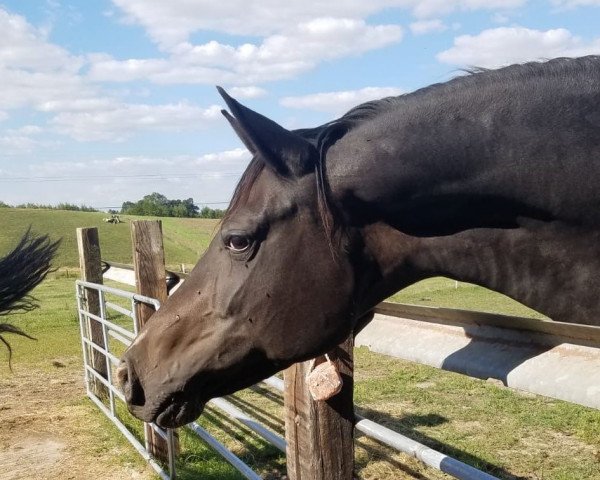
top-left (0, 209), bottom-right (600, 480)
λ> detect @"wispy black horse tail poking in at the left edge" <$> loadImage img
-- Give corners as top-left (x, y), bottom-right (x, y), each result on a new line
top-left (0, 230), bottom-right (59, 362)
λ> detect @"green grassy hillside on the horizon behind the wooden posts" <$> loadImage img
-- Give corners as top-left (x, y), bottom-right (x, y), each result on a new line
top-left (0, 208), bottom-right (218, 267)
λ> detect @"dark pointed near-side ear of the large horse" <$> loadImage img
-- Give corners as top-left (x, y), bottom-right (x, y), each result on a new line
top-left (217, 87), bottom-right (318, 177)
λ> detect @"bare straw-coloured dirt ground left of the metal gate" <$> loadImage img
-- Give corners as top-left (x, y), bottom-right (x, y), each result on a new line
top-left (0, 360), bottom-right (156, 480)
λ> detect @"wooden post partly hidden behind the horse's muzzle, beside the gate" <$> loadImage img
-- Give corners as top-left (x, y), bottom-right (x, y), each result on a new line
top-left (131, 220), bottom-right (179, 461)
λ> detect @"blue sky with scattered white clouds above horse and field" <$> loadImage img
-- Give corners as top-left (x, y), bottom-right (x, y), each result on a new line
top-left (0, 0), bottom-right (600, 208)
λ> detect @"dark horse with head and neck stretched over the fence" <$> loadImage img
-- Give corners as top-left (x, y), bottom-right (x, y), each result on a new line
top-left (119, 56), bottom-right (600, 426)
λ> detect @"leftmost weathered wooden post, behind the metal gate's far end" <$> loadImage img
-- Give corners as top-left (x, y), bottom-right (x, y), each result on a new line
top-left (77, 227), bottom-right (108, 398)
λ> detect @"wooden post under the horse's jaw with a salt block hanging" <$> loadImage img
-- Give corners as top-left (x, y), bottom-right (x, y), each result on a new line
top-left (284, 335), bottom-right (354, 480)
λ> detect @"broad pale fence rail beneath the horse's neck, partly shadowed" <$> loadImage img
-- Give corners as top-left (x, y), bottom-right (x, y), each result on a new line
top-left (356, 303), bottom-right (600, 408)
